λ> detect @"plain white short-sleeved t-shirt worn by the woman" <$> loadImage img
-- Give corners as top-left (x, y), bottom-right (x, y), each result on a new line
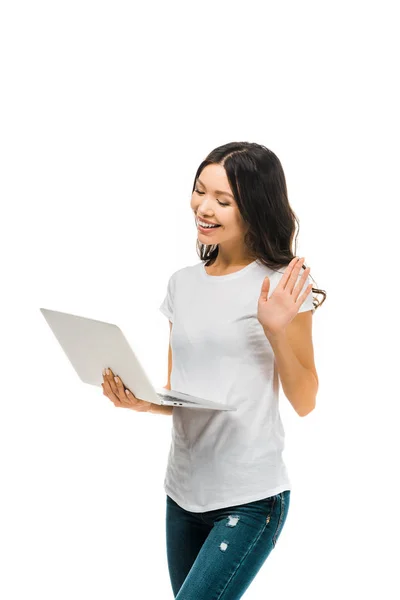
top-left (160, 260), bottom-right (314, 512)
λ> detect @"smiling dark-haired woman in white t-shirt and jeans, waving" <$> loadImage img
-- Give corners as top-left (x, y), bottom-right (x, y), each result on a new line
top-left (100, 142), bottom-right (326, 600)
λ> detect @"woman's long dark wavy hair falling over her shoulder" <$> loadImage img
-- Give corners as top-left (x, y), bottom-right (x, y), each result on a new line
top-left (192, 142), bottom-right (326, 309)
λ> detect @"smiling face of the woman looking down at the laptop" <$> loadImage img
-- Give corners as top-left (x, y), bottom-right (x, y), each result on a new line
top-left (190, 164), bottom-right (246, 246)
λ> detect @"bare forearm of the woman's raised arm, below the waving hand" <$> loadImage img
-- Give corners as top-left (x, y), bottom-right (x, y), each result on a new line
top-left (264, 331), bottom-right (318, 416)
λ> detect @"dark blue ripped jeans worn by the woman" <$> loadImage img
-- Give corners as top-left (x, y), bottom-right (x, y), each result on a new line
top-left (166, 490), bottom-right (290, 600)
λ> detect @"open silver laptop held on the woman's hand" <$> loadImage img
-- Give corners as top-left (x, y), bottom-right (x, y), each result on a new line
top-left (40, 308), bottom-right (237, 410)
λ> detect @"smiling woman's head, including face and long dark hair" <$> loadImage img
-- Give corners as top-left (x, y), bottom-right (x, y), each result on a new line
top-left (190, 142), bottom-right (326, 308)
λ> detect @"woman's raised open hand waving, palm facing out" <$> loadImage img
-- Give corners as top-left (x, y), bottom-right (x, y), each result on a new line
top-left (257, 256), bottom-right (312, 337)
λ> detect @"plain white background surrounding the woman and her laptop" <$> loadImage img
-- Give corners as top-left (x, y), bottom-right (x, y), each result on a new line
top-left (0, 0), bottom-right (400, 600)
